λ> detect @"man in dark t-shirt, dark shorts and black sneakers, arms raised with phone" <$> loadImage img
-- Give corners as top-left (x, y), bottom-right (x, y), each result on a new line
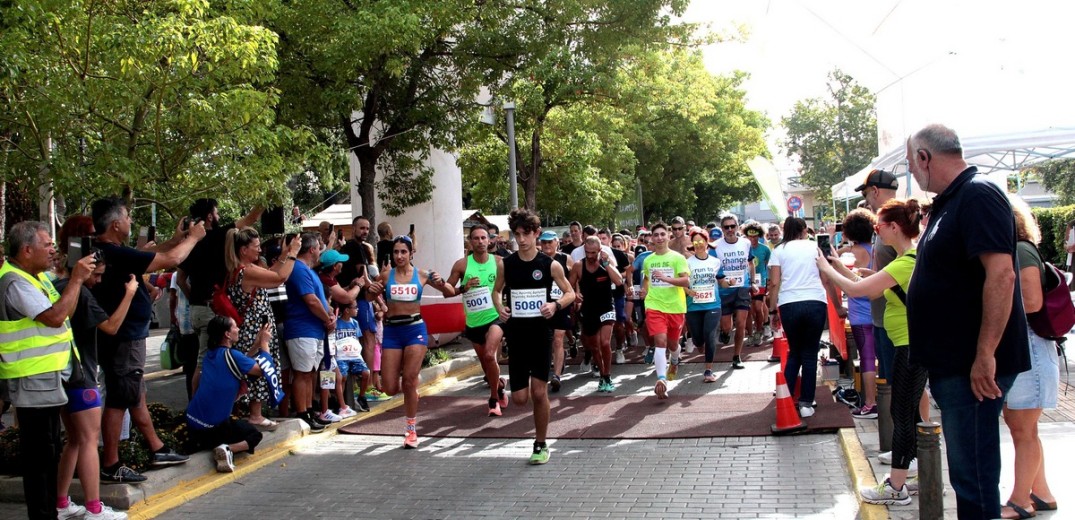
top-left (92, 198), bottom-right (205, 482)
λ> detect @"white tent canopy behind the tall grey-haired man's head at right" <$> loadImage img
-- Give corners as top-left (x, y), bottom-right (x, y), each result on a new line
top-left (832, 128), bottom-right (1075, 201)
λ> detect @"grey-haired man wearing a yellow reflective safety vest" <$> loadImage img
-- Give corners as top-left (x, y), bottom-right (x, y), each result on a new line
top-left (0, 221), bottom-right (96, 519)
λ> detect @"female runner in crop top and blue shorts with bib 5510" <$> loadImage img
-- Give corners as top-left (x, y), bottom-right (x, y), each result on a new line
top-left (369, 235), bottom-right (454, 449)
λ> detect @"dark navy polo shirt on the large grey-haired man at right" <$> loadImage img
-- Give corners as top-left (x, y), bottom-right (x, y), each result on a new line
top-left (907, 167), bottom-right (1030, 376)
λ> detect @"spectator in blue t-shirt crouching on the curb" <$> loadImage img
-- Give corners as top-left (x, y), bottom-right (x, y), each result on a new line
top-left (187, 316), bottom-right (268, 473)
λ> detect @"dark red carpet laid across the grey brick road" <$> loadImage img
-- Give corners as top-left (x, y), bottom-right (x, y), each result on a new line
top-left (340, 387), bottom-right (855, 438)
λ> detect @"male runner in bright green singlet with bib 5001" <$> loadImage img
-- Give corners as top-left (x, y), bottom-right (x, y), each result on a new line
top-left (444, 223), bottom-right (507, 417)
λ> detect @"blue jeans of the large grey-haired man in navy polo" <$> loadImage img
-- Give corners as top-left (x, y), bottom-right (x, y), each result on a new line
top-left (930, 375), bottom-right (1015, 520)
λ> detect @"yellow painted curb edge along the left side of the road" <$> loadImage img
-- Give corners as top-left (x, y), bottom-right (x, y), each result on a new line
top-left (127, 360), bottom-right (482, 520)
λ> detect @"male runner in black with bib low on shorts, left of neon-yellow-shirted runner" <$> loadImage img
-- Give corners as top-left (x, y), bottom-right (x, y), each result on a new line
top-left (571, 236), bottom-right (624, 392)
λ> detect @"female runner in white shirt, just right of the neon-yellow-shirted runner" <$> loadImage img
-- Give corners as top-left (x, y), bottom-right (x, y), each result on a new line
top-left (686, 228), bottom-right (728, 382)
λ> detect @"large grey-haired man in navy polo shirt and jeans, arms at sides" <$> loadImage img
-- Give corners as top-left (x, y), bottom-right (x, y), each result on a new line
top-left (907, 125), bottom-right (1030, 519)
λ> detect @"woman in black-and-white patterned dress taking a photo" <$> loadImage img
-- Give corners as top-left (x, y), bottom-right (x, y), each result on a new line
top-left (224, 228), bottom-right (302, 431)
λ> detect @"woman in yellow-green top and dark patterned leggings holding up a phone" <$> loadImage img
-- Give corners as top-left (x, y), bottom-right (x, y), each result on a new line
top-left (816, 199), bottom-right (927, 505)
